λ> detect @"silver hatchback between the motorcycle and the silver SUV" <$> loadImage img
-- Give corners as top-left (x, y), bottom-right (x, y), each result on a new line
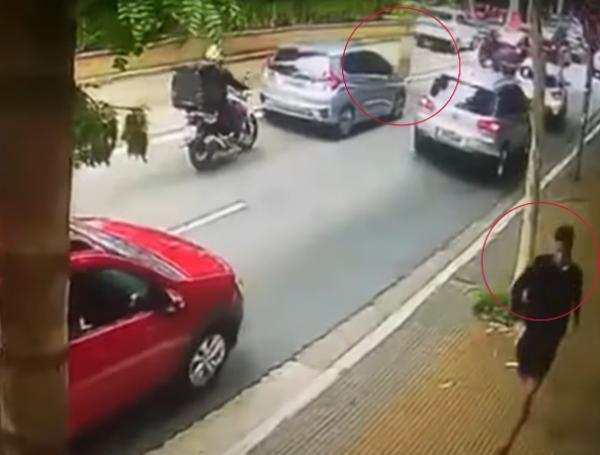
top-left (261, 43), bottom-right (406, 138)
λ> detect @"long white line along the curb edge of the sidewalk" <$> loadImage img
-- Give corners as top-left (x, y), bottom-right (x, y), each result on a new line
top-left (225, 125), bottom-right (600, 455)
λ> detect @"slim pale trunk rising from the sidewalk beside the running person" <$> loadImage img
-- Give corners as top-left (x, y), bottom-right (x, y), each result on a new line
top-left (515, 0), bottom-right (546, 278)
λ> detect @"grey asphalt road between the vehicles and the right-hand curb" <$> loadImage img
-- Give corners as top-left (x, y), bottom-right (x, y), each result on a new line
top-left (73, 52), bottom-right (596, 455)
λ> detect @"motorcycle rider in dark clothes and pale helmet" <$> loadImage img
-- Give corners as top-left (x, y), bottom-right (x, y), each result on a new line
top-left (198, 44), bottom-right (249, 140)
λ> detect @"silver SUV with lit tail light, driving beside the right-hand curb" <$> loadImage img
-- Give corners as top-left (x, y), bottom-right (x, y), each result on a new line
top-left (414, 69), bottom-right (531, 178)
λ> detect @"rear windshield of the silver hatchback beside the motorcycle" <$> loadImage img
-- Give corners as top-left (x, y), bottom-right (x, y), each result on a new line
top-left (270, 48), bottom-right (331, 80)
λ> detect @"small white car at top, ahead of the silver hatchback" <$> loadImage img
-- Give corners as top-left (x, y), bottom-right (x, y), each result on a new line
top-left (415, 8), bottom-right (480, 52)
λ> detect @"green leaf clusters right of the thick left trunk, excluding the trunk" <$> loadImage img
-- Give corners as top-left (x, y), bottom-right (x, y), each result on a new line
top-left (73, 0), bottom-right (244, 166)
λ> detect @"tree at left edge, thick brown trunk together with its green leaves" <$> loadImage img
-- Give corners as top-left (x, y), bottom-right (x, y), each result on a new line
top-left (0, 0), bottom-right (237, 455)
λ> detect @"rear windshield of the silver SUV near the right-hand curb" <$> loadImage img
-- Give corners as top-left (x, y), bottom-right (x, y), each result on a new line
top-left (430, 76), bottom-right (496, 116)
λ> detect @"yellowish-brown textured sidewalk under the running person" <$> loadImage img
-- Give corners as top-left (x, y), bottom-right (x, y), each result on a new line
top-left (244, 146), bottom-right (600, 455)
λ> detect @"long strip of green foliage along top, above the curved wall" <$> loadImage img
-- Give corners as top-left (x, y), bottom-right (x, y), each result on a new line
top-left (78, 0), bottom-right (417, 52)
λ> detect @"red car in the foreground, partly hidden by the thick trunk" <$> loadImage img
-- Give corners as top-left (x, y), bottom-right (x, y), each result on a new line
top-left (69, 218), bottom-right (243, 437)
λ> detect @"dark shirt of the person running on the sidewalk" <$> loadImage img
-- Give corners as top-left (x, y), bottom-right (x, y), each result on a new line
top-left (511, 255), bottom-right (583, 336)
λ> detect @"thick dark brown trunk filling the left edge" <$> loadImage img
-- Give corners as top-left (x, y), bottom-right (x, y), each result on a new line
top-left (0, 0), bottom-right (76, 455)
